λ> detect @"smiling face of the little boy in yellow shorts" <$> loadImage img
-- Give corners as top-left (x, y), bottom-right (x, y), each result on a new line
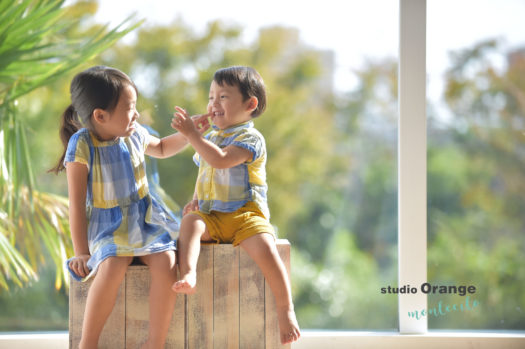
top-left (208, 81), bottom-right (257, 129)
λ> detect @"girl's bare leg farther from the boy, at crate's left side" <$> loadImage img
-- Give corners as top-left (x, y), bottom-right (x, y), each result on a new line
top-left (78, 257), bottom-right (132, 349)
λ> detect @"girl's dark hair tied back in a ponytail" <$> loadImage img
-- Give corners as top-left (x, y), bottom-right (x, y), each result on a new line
top-left (49, 66), bottom-right (138, 174)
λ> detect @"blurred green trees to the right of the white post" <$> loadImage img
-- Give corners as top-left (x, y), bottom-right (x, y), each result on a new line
top-left (428, 40), bottom-right (525, 329)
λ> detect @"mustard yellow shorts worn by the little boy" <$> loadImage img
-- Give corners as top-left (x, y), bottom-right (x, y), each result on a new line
top-left (191, 201), bottom-right (276, 246)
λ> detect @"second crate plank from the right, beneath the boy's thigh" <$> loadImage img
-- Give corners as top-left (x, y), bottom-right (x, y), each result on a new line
top-left (239, 249), bottom-right (265, 349)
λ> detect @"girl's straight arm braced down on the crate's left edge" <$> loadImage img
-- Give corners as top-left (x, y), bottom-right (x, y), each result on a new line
top-left (66, 162), bottom-right (90, 277)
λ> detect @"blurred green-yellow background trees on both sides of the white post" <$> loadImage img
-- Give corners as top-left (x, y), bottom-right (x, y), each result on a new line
top-left (0, 3), bottom-right (525, 329)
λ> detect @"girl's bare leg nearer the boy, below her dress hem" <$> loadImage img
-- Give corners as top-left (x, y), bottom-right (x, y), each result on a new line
top-left (140, 251), bottom-right (177, 349)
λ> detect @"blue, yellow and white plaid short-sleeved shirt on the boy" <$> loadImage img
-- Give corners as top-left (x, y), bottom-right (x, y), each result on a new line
top-left (193, 121), bottom-right (270, 219)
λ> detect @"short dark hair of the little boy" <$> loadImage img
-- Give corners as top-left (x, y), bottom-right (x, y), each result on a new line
top-left (213, 66), bottom-right (266, 118)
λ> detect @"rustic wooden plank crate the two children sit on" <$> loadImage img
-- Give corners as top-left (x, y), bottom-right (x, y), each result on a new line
top-left (69, 240), bottom-right (290, 349)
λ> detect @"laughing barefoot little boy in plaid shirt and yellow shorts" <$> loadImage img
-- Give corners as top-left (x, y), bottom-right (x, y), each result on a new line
top-left (172, 67), bottom-right (300, 344)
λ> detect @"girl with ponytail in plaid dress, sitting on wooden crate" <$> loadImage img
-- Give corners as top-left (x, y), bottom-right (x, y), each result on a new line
top-left (53, 66), bottom-right (208, 348)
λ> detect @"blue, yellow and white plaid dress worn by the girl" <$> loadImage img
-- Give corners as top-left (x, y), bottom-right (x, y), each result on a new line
top-left (64, 124), bottom-right (179, 281)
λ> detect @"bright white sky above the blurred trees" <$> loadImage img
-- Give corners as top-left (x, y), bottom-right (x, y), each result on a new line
top-left (87, 0), bottom-right (525, 100)
